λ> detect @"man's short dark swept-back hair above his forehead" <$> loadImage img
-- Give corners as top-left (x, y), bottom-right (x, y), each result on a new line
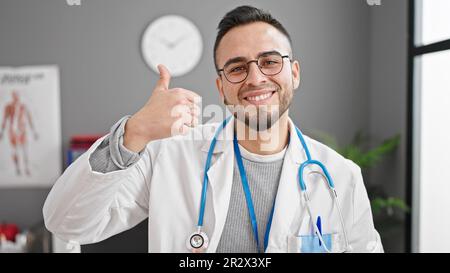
top-left (214, 6), bottom-right (292, 70)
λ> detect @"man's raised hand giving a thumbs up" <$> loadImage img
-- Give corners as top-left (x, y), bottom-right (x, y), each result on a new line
top-left (123, 65), bottom-right (201, 152)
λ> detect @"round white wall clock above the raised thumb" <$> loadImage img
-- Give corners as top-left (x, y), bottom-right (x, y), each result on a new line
top-left (141, 15), bottom-right (203, 77)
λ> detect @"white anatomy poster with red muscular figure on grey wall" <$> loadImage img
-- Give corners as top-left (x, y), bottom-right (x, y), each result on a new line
top-left (0, 66), bottom-right (61, 188)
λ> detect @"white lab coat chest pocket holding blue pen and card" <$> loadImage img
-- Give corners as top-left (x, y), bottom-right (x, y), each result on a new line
top-left (288, 233), bottom-right (345, 253)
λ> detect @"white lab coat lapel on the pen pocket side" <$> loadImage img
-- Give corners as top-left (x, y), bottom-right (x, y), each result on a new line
top-left (267, 119), bottom-right (306, 252)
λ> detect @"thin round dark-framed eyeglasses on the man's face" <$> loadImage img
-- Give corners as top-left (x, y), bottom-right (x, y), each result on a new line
top-left (217, 51), bottom-right (292, 83)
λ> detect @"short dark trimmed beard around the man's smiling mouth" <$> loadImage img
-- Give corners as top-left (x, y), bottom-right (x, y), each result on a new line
top-left (224, 87), bottom-right (293, 132)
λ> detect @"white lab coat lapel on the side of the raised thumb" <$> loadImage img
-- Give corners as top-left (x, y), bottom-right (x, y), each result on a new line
top-left (202, 119), bottom-right (234, 252)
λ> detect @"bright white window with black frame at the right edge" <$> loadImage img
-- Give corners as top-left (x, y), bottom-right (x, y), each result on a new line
top-left (408, 0), bottom-right (450, 252)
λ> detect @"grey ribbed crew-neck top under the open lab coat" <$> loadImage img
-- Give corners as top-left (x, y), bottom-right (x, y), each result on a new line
top-left (217, 145), bottom-right (286, 253)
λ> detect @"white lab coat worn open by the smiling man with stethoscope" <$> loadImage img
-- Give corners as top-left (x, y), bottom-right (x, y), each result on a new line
top-left (43, 118), bottom-right (383, 252)
